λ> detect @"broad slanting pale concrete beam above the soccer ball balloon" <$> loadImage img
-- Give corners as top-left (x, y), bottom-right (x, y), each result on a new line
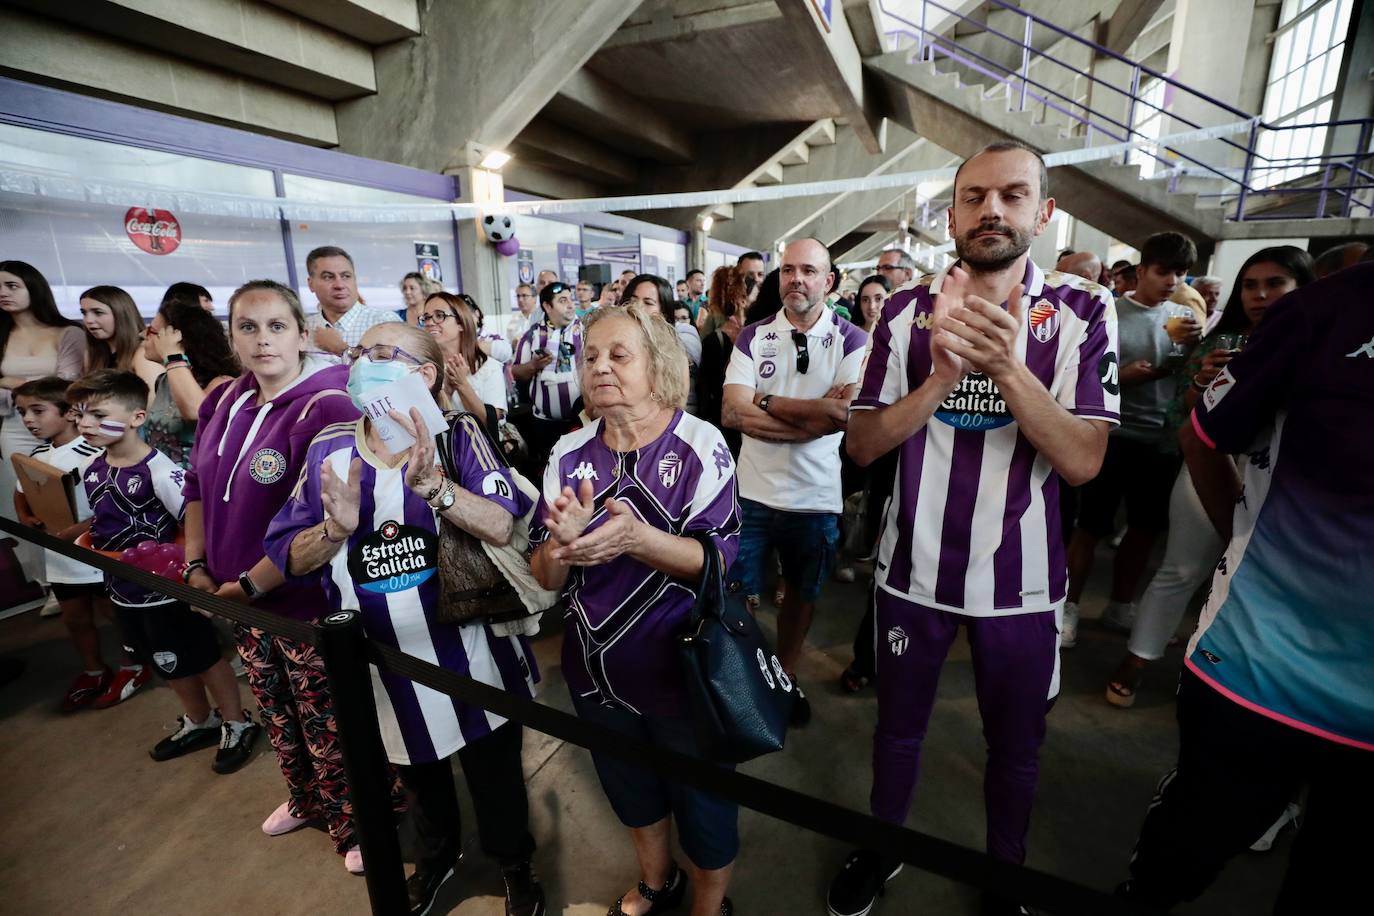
top-left (337, 0), bottom-right (638, 172)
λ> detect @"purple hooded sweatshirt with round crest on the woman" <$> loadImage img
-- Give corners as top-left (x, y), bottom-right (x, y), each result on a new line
top-left (183, 357), bottom-right (359, 621)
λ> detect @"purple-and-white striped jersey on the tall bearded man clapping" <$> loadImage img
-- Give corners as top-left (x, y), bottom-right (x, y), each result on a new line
top-left (852, 261), bottom-right (1120, 617)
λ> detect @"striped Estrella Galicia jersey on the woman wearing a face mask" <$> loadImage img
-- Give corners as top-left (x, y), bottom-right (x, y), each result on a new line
top-left (264, 416), bottom-right (539, 765)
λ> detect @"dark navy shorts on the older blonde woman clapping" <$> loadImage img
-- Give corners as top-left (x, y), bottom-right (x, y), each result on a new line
top-left (573, 695), bottom-right (739, 869)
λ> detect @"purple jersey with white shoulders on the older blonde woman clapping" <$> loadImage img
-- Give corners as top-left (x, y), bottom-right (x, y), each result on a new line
top-left (530, 411), bottom-right (739, 718)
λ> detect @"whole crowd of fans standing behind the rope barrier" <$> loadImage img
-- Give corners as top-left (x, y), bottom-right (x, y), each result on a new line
top-left (0, 143), bottom-right (1374, 916)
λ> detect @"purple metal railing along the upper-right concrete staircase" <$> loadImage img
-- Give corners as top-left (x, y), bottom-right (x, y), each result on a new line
top-left (883, 0), bottom-right (1374, 220)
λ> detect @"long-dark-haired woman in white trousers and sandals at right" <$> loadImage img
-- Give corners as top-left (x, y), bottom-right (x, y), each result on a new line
top-left (1106, 244), bottom-right (1316, 709)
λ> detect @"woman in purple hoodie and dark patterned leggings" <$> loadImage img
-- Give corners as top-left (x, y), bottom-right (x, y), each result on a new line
top-left (184, 280), bottom-right (392, 872)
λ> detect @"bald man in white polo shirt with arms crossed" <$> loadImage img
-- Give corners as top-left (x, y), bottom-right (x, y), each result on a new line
top-left (721, 239), bottom-right (868, 725)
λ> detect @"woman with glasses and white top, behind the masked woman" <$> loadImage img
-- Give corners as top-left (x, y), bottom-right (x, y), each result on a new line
top-left (420, 293), bottom-right (507, 434)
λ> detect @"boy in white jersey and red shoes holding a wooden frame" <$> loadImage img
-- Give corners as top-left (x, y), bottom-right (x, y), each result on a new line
top-left (14, 375), bottom-right (150, 713)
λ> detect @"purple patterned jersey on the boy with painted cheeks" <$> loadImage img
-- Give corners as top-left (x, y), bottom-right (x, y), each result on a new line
top-left (81, 449), bottom-right (185, 607)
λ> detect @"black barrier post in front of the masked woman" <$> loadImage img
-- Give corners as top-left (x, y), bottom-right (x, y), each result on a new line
top-left (320, 611), bottom-right (409, 916)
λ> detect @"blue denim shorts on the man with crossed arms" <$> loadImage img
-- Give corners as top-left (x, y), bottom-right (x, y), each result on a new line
top-left (725, 497), bottom-right (840, 602)
